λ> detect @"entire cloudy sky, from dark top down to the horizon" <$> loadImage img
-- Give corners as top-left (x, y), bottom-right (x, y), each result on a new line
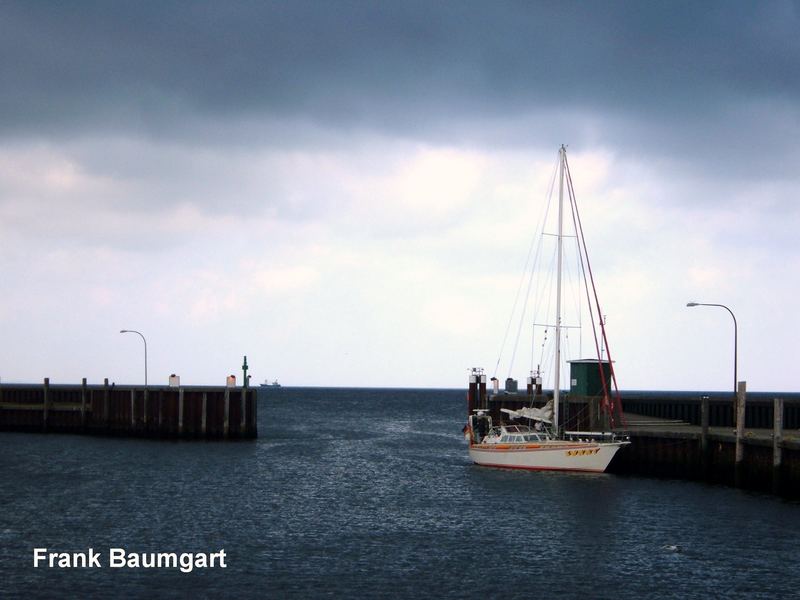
top-left (0, 1), bottom-right (800, 391)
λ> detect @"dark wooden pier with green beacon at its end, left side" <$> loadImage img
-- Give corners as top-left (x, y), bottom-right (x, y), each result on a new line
top-left (0, 379), bottom-right (258, 439)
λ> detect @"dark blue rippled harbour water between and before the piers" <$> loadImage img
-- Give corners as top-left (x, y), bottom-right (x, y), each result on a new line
top-left (0, 388), bottom-right (800, 598)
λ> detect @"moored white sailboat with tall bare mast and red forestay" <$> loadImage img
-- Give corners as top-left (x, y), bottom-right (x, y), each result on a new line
top-left (463, 145), bottom-right (630, 473)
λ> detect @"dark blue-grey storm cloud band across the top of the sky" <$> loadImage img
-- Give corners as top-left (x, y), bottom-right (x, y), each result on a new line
top-left (0, 1), bottom-right (800, 143)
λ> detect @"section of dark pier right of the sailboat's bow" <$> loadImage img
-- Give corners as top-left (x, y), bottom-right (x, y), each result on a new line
top-left (609, 392), bottom-right (800, 497)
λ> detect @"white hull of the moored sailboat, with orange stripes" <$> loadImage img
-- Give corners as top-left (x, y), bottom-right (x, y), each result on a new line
top-left (469, 441), bottom-right (630, 473)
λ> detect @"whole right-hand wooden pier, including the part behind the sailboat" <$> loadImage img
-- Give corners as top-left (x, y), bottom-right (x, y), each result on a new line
top-left (478, 381), bottom-right (800, 497)
